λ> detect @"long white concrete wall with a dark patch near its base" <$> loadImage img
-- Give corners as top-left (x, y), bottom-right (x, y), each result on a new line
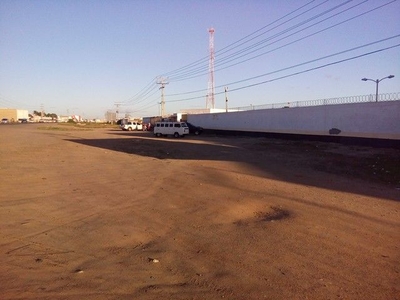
top-left (188, 101), bottom-right (400, 140)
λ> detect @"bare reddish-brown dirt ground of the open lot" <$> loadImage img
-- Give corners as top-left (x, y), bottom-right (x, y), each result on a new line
top-left (0, 124), bottom-right (400, 300)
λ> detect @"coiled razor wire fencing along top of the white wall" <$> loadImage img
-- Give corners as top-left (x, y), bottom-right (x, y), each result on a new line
top-left (229, 92), bottom-right (400, 111)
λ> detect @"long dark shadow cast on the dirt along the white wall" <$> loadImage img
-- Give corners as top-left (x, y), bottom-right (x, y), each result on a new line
top-left (68, 131), bottom-right (400, 201)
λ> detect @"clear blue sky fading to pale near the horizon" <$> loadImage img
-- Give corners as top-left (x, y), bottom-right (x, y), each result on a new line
top-left (0, 0), bottom-right (400, 118)
